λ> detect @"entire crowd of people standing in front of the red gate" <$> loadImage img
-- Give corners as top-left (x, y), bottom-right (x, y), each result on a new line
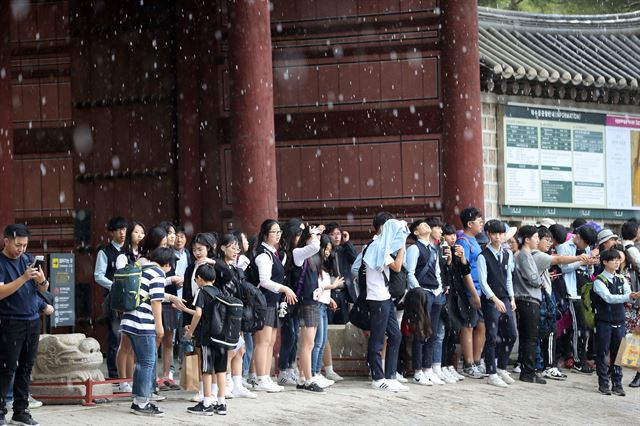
top-left (0, 207), bottom-right (640, 424)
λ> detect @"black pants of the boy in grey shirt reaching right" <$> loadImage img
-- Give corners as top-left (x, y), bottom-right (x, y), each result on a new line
top-left (516, 300), bottom-right (540, 377)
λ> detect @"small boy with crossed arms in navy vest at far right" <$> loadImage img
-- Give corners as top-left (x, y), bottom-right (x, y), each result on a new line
top-left (591, 248), bottom-right (640, 396)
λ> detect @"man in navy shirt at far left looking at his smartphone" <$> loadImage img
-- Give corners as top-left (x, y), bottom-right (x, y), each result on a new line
top-left (0, 224), bottom-right (49, 426)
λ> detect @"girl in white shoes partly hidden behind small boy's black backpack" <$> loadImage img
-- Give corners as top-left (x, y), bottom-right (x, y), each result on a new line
top-left (215, 234), bottom-right (256, 398)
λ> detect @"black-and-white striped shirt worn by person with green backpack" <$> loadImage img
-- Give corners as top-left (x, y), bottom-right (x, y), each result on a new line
top-left (120, 265), bottom-right (165, 336)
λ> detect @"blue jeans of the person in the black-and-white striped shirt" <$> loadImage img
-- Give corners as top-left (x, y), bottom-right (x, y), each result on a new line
top-left (127, 333), bottom-right (157, 400)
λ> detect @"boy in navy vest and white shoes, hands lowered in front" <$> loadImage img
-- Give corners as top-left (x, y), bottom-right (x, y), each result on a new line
top-left (477, 219), bottom-right (516, 387)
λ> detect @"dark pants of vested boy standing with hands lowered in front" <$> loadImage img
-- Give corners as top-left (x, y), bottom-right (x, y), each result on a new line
top-left (482, 297), bottom-right (517, 374)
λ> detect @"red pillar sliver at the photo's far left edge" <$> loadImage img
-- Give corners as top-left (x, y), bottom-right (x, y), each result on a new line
top-left (0, 1), bottom-right (16, 231)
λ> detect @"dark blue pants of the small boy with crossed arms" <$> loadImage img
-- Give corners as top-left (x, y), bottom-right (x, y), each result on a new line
top-left (596, 321), bottom-right (626, 386)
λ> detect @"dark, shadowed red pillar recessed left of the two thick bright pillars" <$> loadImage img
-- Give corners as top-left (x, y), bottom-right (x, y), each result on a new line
top-left (176, 0), bottom-right (202, 232)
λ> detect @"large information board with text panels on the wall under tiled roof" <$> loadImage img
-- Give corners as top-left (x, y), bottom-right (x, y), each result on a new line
top-left (500, 105), bottom-right (640, 218)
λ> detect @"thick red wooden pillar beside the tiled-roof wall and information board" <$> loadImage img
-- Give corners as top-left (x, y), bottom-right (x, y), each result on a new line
top-left (441, 0), bottom-right (484, 224)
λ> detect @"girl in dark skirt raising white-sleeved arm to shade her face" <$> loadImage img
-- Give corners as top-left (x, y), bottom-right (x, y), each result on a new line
top-left (292, 227), bottom-right (328, 392)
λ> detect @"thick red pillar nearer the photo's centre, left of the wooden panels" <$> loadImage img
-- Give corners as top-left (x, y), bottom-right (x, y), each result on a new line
top-left (229, 0), bottom-right (278, 233)
